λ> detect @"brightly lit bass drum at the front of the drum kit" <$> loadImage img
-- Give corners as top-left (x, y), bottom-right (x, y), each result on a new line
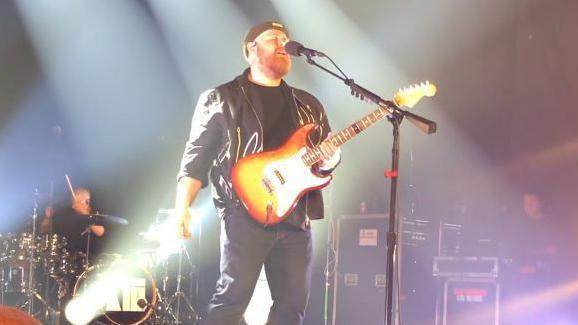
top-left (73, 261), bottom-right (157, 325)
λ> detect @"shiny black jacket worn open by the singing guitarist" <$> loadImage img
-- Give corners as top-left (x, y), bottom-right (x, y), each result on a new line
top-left (177, 69), bottom-right (330, 227)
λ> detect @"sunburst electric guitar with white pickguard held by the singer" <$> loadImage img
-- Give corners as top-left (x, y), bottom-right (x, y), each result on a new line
top-left (231, 81), bottom-right (436, 226)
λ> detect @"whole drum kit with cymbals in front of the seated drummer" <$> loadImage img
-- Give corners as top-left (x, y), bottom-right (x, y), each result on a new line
top-left (0, 201), bottom-right (199, 325)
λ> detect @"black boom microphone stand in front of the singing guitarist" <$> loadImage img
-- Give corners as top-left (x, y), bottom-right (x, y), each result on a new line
top-left (305, 53), bottom-right (436, 325)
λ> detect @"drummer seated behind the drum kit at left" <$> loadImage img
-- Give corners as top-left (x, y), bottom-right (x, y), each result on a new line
top-left (41, 187), bottom-right (105, 251)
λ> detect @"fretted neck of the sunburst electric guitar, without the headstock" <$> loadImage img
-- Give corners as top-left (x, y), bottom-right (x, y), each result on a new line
top-left (302, 107), bottom-right (389, 166)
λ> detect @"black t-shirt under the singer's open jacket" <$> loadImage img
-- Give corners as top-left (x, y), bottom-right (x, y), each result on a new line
top-left (251, 83), bottom-right (295, 151)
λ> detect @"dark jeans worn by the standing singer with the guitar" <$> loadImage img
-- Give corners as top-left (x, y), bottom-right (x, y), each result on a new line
top-left (203, 217), bottom-right (313, 325)
